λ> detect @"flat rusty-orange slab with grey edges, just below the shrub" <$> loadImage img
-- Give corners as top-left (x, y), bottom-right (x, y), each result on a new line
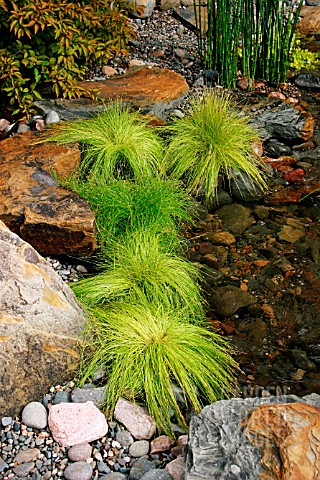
top-left (35, 66), bottom-right (189, 120)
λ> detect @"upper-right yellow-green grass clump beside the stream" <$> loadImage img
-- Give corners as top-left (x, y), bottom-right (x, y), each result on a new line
top-left (165, 92), bottom-right (266, 203)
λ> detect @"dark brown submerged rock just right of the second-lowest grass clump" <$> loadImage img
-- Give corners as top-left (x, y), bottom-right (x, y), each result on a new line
top-left (211, 285), bottom-right (255, 317)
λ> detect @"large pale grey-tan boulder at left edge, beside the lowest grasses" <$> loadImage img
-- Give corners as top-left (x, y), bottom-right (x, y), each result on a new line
top-left (0, 221), bottom-right (85, 418)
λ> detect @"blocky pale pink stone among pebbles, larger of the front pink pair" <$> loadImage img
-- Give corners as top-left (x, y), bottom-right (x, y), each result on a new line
top-left (48, 402), bottom-right (108, 447)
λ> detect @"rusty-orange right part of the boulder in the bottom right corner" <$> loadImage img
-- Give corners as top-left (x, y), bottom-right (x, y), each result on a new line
top-left (245, 403), bottom-right (320, 480)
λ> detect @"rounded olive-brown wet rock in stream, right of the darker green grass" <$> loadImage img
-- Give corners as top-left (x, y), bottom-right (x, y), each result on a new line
top-left (215, 203), bottom-right (254, 234)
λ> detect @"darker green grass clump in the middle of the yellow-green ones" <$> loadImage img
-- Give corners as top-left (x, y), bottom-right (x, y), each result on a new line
top-left (64, 177), bottom-right (194, 257)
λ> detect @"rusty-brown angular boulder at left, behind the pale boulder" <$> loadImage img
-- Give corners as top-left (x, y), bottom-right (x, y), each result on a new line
top-left (0, 129), bottom-right (96, 256)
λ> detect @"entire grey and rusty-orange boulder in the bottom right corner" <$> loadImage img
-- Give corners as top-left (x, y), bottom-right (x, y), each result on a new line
top-left (185, 394), bottom-right (320, 480)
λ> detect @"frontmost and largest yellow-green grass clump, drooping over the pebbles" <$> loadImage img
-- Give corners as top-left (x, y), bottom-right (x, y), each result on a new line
top-left (81, 299), bottom-right (237, 435)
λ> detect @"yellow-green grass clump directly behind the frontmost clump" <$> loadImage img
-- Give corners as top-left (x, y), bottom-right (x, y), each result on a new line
top-left (72, 230), bottom-right (203, 323)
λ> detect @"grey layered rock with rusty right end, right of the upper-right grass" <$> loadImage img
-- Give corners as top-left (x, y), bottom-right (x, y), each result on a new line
top-left (253, 105), bottom-right (314, 141)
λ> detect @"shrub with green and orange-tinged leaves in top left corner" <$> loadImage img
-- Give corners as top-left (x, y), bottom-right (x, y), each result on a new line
top-left (0, 0), bottom-right (133, 113)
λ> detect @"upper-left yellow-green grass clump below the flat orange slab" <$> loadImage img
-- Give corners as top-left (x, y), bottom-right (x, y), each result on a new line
top-left (46, 100), bottom-right (163, 185)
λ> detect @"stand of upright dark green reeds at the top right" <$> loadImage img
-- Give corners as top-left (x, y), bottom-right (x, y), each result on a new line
top-left (194, 0), bottom-right (303, 88)
